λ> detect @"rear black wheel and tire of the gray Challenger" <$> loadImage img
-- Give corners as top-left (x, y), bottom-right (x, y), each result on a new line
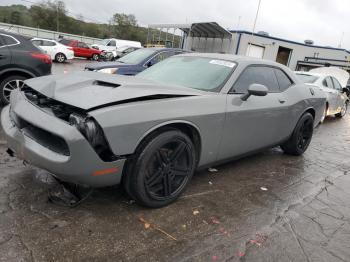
top-left (281, 113), bottom-right (314, 156)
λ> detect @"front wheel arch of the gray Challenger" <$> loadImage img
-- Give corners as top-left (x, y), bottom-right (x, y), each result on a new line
top-left (136, 120), bottom-right (202, 163)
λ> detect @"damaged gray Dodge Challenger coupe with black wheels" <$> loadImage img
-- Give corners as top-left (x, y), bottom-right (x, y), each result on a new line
top-left (1, 54), bottom-right (326, 207)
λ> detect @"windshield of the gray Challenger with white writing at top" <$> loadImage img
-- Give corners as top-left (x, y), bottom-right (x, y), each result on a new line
top-left (138, 56), bottom-right (236, 91)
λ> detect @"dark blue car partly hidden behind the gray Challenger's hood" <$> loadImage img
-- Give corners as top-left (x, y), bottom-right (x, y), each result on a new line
top-left (85, 48), bottom-right (187, 75)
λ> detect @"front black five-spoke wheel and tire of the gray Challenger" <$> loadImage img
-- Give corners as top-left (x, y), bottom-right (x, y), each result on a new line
top-left (123, 129), bottom-right (197, 208)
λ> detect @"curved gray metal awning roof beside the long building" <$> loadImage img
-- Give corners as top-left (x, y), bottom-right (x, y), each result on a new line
top-left (179, 22), bottom-right (232, 38)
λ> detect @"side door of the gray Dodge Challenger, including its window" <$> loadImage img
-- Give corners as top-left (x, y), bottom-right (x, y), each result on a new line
top-left (218, 65), bottom-right (292, 159)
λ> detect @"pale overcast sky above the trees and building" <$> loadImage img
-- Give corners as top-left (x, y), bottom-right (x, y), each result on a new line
top-left (0, 0), bottom-right (350, 49)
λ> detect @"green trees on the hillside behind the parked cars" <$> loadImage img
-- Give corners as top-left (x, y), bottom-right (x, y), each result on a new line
top-left (0, 0), bottom-right (179, 46)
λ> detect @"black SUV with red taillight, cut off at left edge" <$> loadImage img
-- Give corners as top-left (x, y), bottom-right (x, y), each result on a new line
top-left (0, 30), bottom-right (52, 104)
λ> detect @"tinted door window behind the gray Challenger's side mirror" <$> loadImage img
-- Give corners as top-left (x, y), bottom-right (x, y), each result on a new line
top-left (232, 66), bottom-right (280, 93)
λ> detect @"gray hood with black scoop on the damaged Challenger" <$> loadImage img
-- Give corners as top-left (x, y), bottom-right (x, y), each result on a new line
top-left (25, 72), bottom-right (207, 110)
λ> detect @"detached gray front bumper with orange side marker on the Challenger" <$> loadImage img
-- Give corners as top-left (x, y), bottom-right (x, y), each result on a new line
top-left (1, 90), bottom-right (126, 187)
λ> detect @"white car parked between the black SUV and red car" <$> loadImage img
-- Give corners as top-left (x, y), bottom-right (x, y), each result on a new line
top-left (31, 38), bottom-right (74, 63)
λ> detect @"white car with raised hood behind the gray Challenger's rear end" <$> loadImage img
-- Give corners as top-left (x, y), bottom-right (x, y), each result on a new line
top-left (295, 72), bottom-right (349, 121)
